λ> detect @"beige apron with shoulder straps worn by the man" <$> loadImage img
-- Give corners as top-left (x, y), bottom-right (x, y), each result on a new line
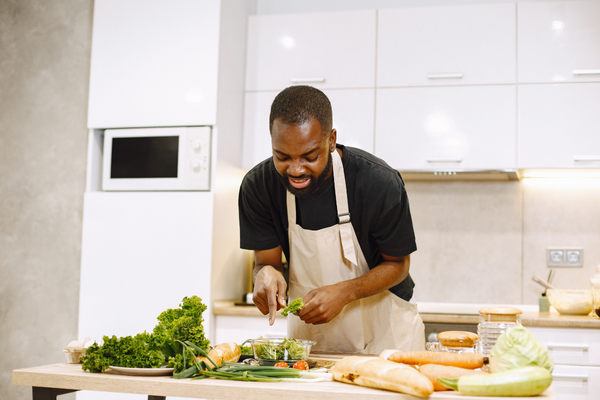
top-left (287, 151), bottom-right (425, 354)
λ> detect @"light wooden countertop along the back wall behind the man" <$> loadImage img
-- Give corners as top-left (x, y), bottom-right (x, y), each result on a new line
top-left (212, 300), bottom-right (600, 329)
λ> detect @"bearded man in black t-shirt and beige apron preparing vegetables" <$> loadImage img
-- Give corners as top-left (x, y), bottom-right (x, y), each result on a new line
top-left (239, 86), bottom-right (425, 354)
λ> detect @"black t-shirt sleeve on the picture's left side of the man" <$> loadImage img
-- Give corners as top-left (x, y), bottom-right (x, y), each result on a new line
top-left (238, 171), bottom-right (280, 250)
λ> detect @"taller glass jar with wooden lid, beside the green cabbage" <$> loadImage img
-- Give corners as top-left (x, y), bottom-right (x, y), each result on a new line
top-left (477, 306), bottom-right (523, 368)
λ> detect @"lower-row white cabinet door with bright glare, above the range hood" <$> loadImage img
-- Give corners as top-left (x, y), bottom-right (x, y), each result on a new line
top-left (375, 85), bottom-right (516, 171)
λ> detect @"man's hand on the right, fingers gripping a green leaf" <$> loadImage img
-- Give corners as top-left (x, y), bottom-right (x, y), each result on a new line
top-left (298, 281), bottom-right (353, 325)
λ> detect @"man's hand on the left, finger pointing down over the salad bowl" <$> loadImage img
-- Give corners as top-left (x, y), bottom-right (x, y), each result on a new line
top-left (252, 265), bottom-right (287, 325)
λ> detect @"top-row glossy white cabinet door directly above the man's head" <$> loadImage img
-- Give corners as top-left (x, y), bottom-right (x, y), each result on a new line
top-left (246, 10), bottom-right (376, 91)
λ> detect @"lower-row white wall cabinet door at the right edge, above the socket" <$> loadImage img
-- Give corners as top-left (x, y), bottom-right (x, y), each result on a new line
top-left (518, 83), bottom-right (600, 168)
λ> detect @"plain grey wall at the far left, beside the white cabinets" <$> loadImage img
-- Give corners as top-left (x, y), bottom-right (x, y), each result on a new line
top-left (0, 0), bottom-right (93, 399)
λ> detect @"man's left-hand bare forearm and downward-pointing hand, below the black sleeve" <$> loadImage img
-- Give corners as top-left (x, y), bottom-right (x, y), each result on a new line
top-left (252, 246), bottom-right (287, 325)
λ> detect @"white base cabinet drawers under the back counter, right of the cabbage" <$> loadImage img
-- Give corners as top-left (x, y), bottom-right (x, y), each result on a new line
top-left (527, 327), bottom-right (600, 400)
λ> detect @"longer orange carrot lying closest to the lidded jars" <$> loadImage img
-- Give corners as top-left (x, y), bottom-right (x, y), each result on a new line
top-left (379, 350), bottom-right (483, 369)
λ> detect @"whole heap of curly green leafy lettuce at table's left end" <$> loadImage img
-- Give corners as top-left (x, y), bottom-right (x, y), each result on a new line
top-left (81, 296), bottom-right (210, 372)
